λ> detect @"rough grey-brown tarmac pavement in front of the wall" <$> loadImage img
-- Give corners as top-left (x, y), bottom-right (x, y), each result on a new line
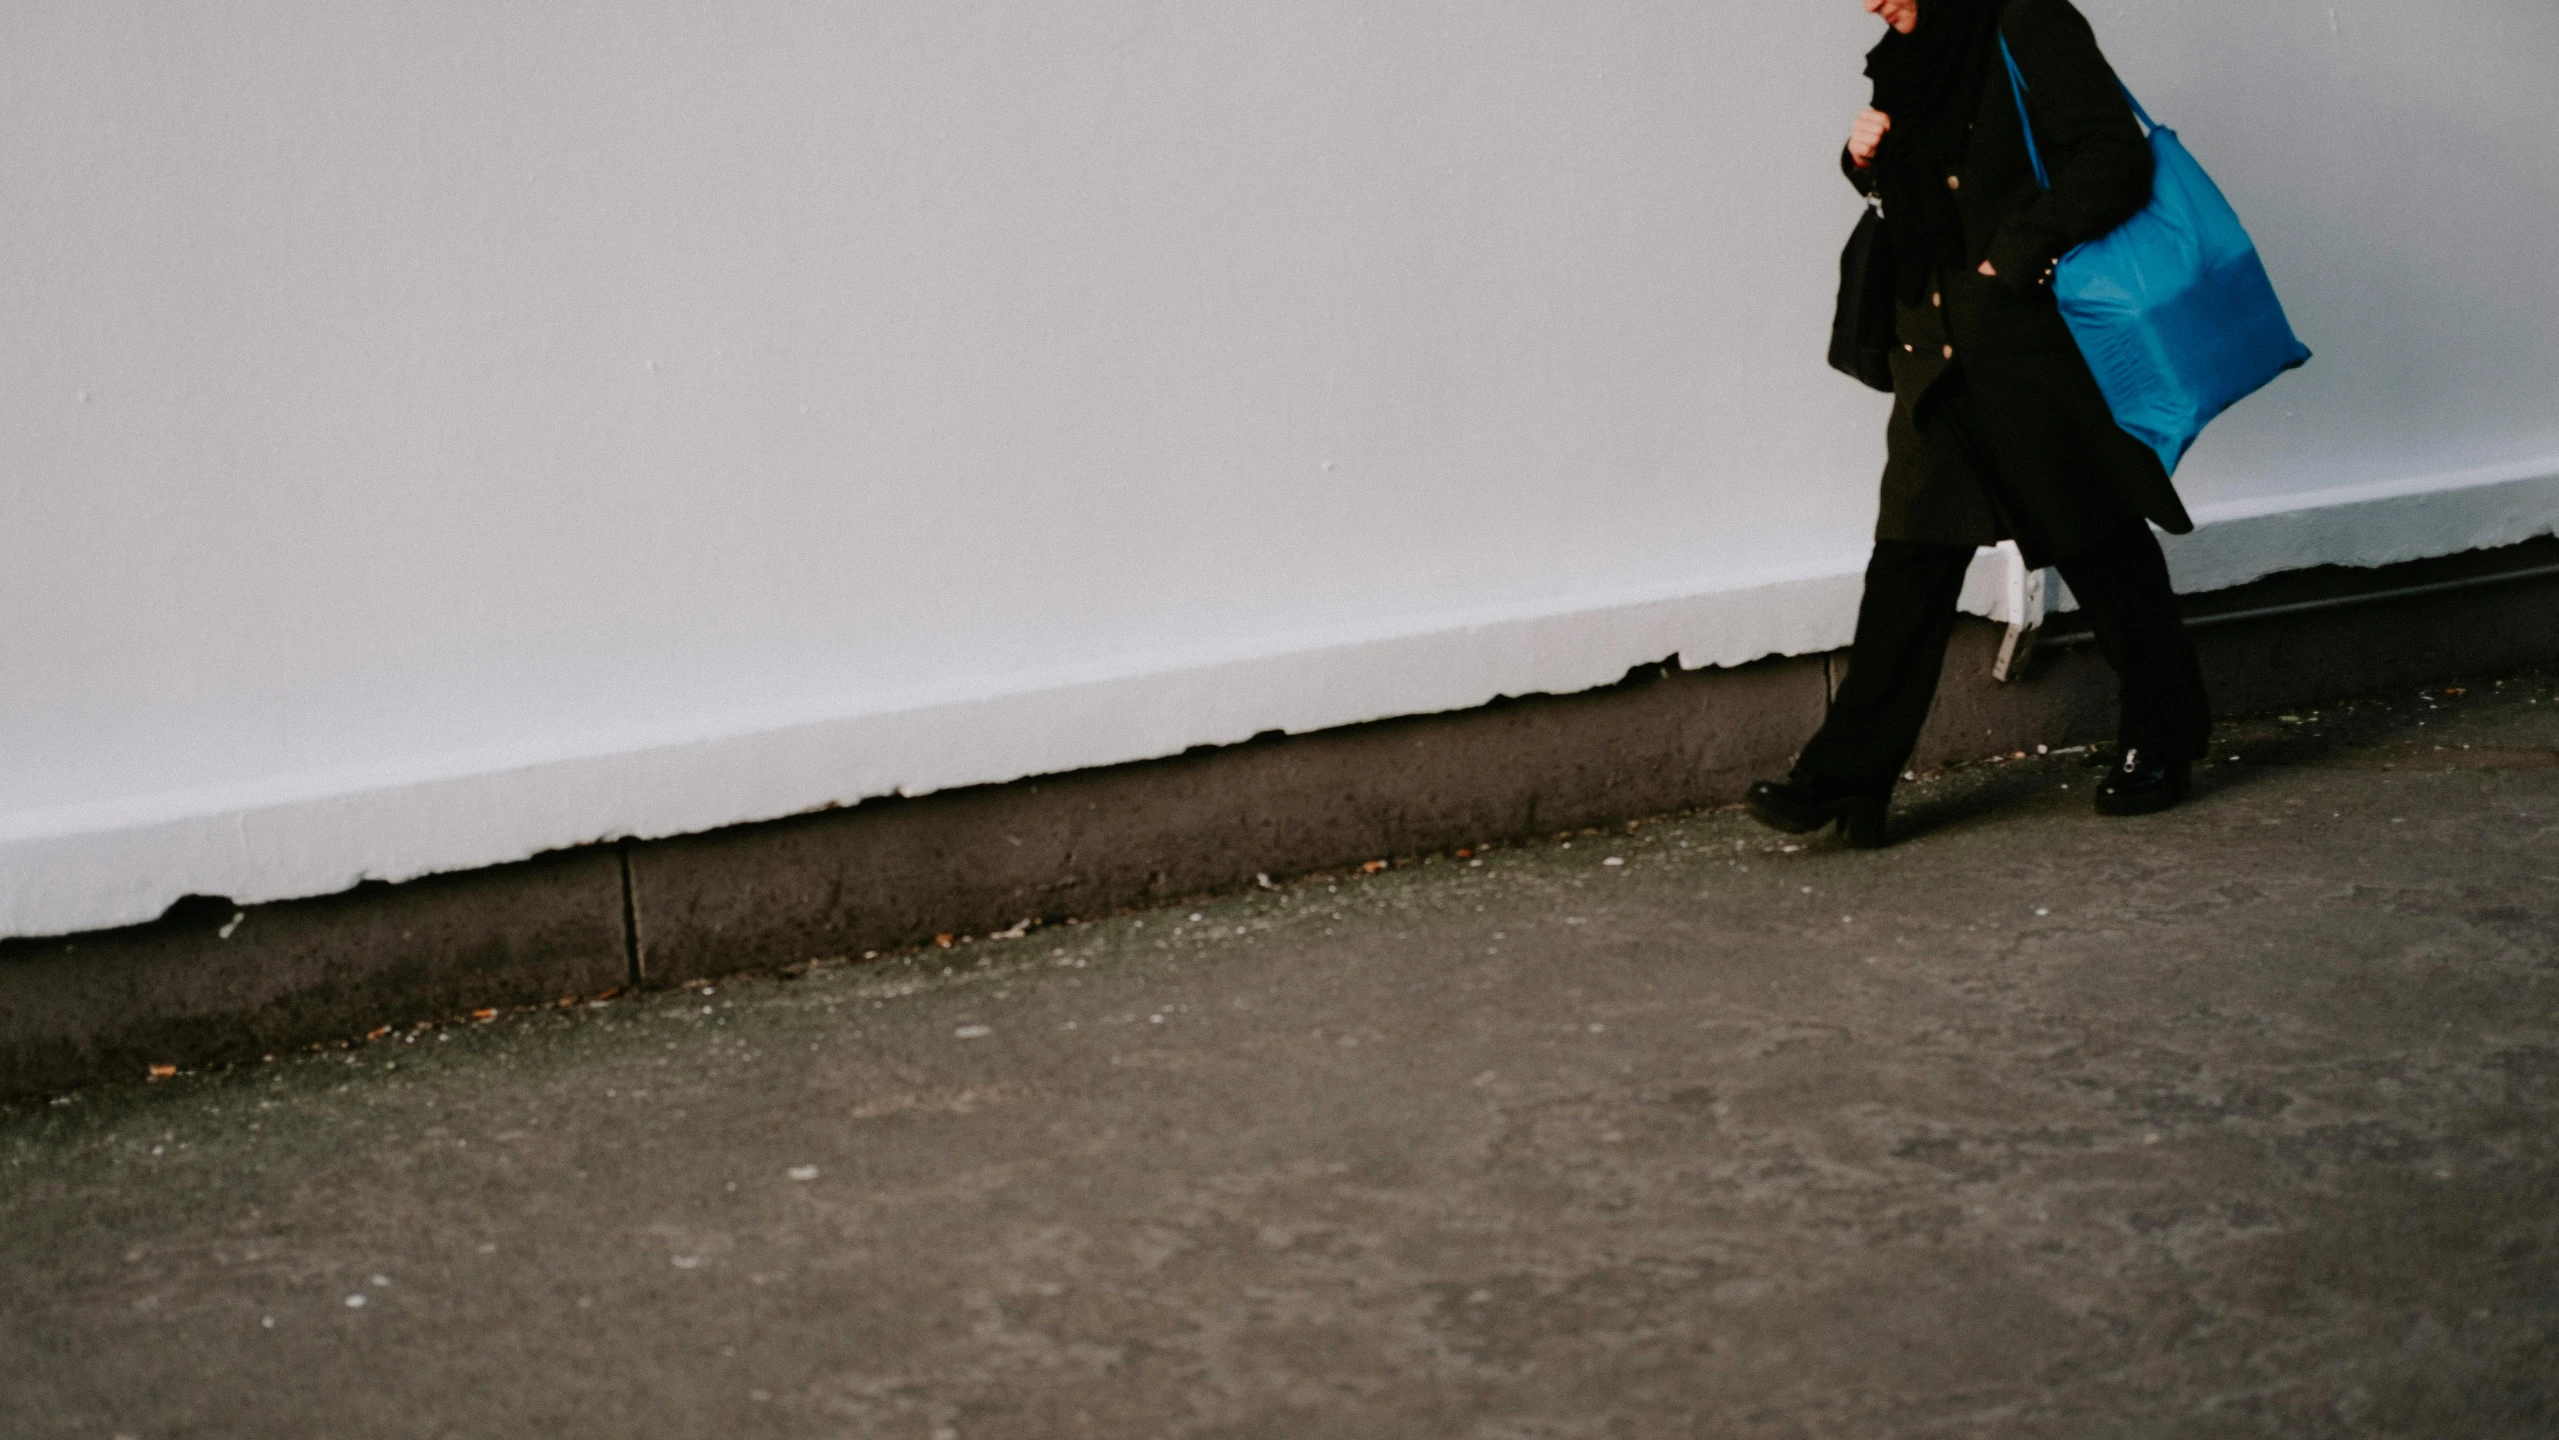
top-left (0, 673), bottom-right (2559, 1440)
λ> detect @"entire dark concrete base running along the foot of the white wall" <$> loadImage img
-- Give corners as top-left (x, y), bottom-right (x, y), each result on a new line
top-left (15, 540), bottom-right (2559, 1095)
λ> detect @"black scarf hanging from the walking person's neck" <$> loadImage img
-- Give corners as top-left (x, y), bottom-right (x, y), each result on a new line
top-left (1866, 0), bottom-right (2006, 304)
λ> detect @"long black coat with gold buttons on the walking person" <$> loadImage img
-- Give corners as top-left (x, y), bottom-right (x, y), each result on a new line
top-left (1840, 0), bottom-right (2196, 565)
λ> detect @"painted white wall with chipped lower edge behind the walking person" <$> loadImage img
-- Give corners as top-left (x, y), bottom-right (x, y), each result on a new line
top-left (0, 0), bottom-right (2559, 934)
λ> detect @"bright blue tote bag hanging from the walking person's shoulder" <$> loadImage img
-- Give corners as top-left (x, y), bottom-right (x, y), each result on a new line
top-left (1999, 36), bottom-right (2311, 476)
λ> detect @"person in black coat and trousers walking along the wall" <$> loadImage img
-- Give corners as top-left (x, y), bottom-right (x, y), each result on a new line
top-left (1750, 0), bottom-right (2211, 847)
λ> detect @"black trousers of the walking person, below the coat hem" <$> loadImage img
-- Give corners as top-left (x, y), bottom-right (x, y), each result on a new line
top-left (1794, 524), bottom-right (2214, 790)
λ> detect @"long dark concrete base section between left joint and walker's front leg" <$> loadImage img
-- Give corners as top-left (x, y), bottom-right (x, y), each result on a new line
top-left (632, 647), bottom-right (1827, 982)
